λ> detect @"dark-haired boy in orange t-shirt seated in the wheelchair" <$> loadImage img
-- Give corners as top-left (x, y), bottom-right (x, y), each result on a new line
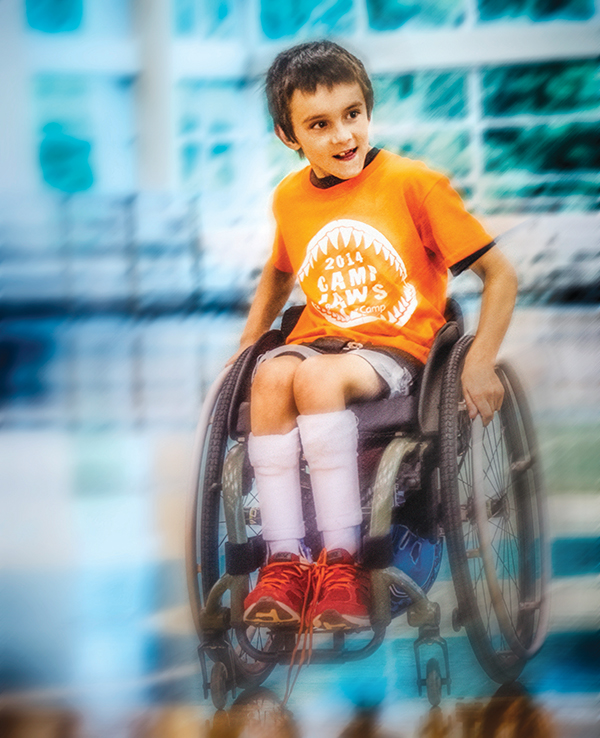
top-left (231, 41), bottom-right (516, 630)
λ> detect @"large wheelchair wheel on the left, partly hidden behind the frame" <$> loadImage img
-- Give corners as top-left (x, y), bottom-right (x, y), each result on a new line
top-left (186, 356), bottom-right (274, 688)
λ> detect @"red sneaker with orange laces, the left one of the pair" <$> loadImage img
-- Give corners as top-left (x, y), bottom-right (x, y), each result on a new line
top-left (244, 553), bottom-right (312, 626)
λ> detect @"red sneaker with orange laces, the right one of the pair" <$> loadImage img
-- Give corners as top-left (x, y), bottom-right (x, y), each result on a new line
top-left (311, 548), bottom-right (371, 630)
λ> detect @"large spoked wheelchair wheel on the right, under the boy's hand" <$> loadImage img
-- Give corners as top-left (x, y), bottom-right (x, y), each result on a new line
top-left (440, 336), bottom-right (549, 683)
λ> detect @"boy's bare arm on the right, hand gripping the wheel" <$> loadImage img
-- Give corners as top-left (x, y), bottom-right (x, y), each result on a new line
top-left (461, 246), bottom-right (517, 425)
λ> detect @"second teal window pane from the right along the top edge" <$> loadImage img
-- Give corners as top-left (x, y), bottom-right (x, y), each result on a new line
top-left (366, 0), bottom-right (465, 31)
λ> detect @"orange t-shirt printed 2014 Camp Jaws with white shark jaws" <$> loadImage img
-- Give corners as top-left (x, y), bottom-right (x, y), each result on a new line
top-left (272, 151), bottom-right (492, 362)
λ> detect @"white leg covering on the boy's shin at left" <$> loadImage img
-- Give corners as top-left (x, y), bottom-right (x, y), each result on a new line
top-left (248, 428), bottom-right (304, 553)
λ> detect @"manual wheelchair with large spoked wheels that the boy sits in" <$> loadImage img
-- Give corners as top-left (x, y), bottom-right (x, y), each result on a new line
top-left (186, 300), bottom-right (549, 709)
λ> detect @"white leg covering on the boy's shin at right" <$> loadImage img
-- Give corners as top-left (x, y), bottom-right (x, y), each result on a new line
top-left (297, 410), bottom-right (362, 554)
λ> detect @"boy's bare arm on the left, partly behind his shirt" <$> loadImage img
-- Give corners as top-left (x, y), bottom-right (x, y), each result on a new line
top-left (227, 259), bottom-right (296, 365)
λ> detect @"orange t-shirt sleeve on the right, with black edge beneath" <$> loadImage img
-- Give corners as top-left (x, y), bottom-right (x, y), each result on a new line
top-left (420, 177), bottom-right (493, 269)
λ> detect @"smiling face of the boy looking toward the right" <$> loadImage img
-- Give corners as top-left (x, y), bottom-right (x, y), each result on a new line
top-left (275, 82), bottom-right (370, 179)
